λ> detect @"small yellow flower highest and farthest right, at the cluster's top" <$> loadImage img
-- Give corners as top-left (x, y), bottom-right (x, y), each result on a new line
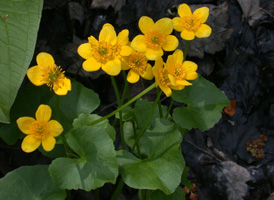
top-left (172, 4), bottom-right (212, 40)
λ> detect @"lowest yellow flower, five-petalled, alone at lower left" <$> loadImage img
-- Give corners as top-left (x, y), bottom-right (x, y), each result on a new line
top-left (16, 104), bottom-right (63, 153)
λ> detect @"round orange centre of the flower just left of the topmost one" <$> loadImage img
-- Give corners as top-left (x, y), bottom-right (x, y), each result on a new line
top-left (145, 29), bottom-right (165, 50)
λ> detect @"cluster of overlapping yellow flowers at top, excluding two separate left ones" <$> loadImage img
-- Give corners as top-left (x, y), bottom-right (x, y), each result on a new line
top-left (78, 4), bottom-right (211, 97)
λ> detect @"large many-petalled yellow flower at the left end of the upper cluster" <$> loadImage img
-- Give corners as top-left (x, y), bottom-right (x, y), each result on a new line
top-left (77, 24), bottom-right (132, 76)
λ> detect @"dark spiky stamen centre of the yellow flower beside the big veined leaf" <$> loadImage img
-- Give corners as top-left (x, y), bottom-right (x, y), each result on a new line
top-left (42, 64), bottom-right (65, 90)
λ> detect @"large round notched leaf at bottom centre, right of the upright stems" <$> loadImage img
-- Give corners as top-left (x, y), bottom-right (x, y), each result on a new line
top-left (117, 119), bottom-right (185, 195)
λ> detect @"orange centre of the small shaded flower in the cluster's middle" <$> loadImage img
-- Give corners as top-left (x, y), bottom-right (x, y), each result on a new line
top-left (128, 52), bottom-right (147, 74)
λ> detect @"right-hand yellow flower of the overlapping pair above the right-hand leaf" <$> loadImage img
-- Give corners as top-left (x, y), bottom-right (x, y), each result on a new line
top-left (165, 49), bottom-right (198, 86)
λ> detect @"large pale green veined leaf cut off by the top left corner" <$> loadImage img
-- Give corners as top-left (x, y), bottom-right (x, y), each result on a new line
top-left (0, 0), bottom-right (43, 123)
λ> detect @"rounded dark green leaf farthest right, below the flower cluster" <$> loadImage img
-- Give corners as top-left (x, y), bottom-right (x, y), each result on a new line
top-left (172, 76), bottom-right (230, 131)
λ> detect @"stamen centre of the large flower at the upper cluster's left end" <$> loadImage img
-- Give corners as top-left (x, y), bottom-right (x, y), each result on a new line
top-left (92, 41), bottom-right (115, 63)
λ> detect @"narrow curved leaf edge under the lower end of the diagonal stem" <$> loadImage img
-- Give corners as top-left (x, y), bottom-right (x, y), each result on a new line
top-left (72, 113), bottom-right (116, 141)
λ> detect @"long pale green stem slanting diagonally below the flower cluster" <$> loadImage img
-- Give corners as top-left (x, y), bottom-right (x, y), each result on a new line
top-left (89, 83), bottom-right (155, 126)
